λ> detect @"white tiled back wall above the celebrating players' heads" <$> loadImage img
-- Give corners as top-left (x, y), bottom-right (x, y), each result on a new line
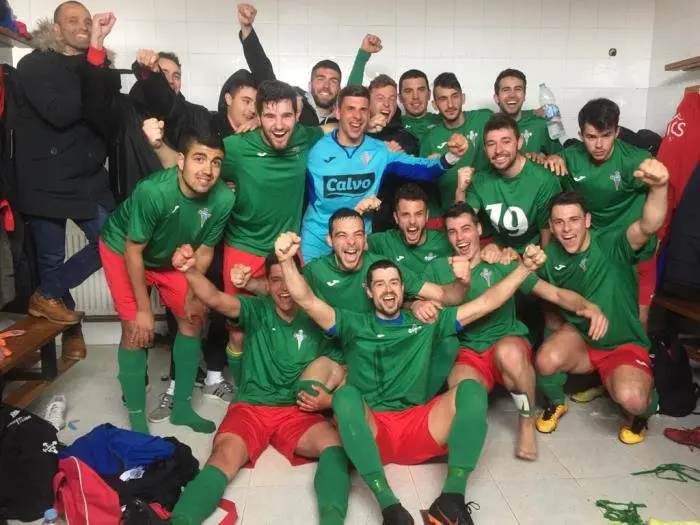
top-left (11, 0), bottom-right (660, 139)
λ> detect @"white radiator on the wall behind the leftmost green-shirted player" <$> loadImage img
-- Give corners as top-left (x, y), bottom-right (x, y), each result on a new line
top-left (66, 221), bottom-right (164, 318)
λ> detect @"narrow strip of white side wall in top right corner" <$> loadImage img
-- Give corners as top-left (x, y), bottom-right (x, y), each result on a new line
top-left (647, 0), bottom-right (700, 134)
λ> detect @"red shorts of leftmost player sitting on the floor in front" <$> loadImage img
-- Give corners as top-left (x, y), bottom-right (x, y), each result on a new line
top-left (216, 403), bottom-right (325, 466)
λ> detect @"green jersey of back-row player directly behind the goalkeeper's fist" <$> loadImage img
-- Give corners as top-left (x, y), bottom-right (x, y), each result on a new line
top-left (420, 109), bottom-right (493, 217)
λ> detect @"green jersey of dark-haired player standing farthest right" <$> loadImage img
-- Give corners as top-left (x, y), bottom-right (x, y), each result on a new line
top-left (561, 140), bottom-right (650, 233)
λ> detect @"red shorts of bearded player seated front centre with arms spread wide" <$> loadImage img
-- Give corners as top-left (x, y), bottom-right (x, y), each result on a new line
top-left (372, 397), bottom-right (447, 465)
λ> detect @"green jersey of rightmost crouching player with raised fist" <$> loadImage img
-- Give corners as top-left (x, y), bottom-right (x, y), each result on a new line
top-left (538, 230), bottom-right (655, 350)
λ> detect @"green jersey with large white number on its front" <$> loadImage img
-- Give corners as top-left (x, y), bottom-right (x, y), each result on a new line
top-left (467, 160), bottom-right (561, 253)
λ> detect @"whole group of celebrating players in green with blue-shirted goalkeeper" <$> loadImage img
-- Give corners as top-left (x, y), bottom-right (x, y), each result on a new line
top-left (89, 1), bottom-right (668, 525)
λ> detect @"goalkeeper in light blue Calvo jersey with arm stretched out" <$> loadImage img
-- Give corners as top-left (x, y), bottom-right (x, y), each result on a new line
top-left (301, 86), bottom-right (469, 263)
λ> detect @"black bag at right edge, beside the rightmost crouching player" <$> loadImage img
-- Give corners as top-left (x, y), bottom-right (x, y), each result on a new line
top-left (649, 335), bottom-right (700, 417)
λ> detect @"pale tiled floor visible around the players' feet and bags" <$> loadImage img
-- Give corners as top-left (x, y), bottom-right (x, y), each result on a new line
top-left (9, 346), bottom-right (700, 525)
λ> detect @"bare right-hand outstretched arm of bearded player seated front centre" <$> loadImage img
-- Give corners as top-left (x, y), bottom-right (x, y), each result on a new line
top-left (457, 245), bottom-right (547, 326)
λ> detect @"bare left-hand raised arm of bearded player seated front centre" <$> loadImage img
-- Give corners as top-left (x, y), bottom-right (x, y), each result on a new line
top-left (275, 232), bottom-right (335, 330)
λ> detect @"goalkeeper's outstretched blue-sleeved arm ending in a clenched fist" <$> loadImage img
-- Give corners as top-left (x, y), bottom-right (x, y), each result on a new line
top-left (384, 133), bottom-right (469, 181)
